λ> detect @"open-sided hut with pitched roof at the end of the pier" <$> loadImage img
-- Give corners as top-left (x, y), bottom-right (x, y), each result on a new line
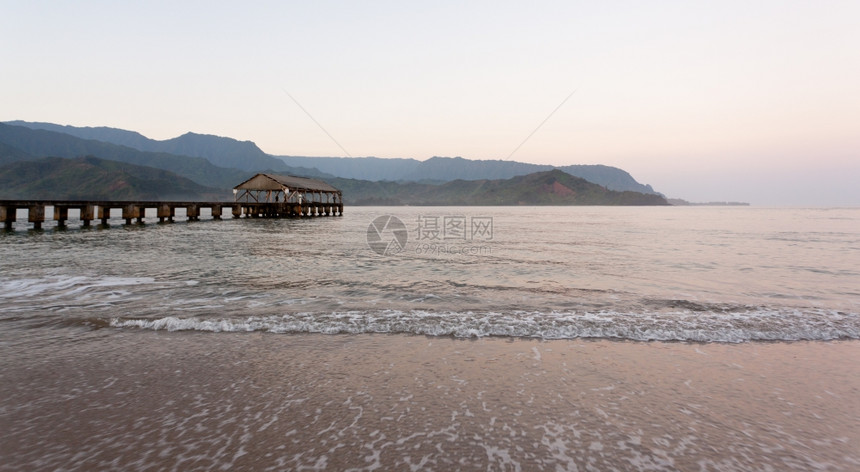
top-left (233, 174), bottom-right (343, 216)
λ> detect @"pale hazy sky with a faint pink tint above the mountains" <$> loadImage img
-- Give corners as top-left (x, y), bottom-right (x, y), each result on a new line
top-left (0, 0), bottom-right (860, 205)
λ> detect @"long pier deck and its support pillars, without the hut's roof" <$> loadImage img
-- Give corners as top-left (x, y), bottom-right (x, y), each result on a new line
top-left (0, 200), bottom-right (343, 230)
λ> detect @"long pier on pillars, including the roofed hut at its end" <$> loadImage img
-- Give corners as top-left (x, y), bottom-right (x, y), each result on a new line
top-left (0, 174), bottom-right (343, 230)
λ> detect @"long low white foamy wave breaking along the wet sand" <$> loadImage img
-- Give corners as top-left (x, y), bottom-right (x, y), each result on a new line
top-left (110, 310), bottom-right (860, 343)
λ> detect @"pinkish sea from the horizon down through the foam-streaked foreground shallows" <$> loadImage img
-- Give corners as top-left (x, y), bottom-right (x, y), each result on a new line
top-left (0, 207), bottom-right (860, 470)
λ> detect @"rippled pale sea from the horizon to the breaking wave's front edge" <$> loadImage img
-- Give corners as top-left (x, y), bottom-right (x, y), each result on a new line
top-left (0, 207), bottom-right (860, 342)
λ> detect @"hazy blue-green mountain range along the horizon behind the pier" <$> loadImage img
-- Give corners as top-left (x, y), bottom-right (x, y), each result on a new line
top-left (0, 121), bottom-right (665, 204)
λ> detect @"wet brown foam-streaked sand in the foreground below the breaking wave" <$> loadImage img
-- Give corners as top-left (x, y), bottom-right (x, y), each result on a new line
top-left (0, 328), bottom-right (860, 470)
